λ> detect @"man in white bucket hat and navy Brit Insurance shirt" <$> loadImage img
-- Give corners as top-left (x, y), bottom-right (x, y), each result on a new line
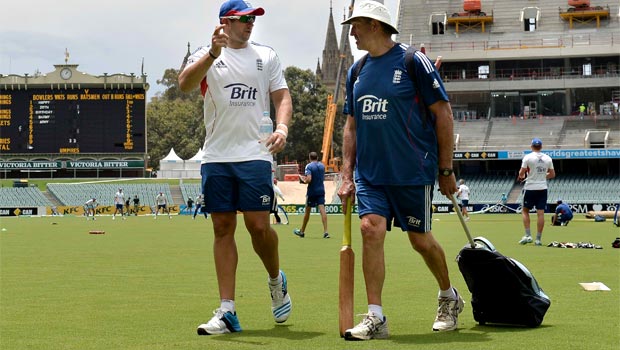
top-left (338, 0), bottom-right (464, 340)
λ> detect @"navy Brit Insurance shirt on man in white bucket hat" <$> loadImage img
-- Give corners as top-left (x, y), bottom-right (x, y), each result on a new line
top-left (343, 44), bottom-right (448, 185)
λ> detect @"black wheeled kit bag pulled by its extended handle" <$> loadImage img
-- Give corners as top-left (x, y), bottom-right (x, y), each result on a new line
top-left (451, 197), bottom-right (551, 327)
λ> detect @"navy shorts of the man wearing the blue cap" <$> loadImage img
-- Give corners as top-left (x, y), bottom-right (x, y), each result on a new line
top-left (200, 160), bottom-right (274, 213)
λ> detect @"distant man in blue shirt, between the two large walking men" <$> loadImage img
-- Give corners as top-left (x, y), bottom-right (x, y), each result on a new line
top-left (293, 152), bottom-right (329, 238)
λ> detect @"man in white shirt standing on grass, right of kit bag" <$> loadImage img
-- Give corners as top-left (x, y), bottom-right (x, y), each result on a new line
top-left (519, 138), bottom-right (555, 246)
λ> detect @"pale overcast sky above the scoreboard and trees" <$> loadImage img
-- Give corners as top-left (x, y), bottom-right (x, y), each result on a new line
top-left (0, 0), bottom-right (398, 96)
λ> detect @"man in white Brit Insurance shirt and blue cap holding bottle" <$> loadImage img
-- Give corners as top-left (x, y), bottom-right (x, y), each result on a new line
top-left (179, 0), bottom-right (293, 335)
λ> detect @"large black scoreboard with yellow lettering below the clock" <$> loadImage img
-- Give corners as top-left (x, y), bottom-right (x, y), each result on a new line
top-left (0, 88), bottom-right (146, 155)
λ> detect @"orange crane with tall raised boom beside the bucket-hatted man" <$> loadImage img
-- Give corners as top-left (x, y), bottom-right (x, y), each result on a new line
top-left (321, 0), bottom-right (355, 172)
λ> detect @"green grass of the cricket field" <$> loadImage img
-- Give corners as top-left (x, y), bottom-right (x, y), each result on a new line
top-left (0, 214), bottom-right (620, 350)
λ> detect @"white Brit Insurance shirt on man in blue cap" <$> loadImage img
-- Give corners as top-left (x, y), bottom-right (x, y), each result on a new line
top-left (187, 42), bottom-right (288, 163)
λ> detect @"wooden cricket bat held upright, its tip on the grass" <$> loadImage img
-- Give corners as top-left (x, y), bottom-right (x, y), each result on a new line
top-left (338, 198), bottom-right (355, 337)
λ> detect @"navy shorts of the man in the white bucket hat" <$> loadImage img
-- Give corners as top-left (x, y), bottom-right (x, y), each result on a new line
top-left (355, 179), bottom-right (434, 232)
